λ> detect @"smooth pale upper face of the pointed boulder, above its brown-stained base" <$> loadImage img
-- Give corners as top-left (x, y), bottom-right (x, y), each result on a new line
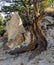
top-left (6, 12), bottom-right (25, 40)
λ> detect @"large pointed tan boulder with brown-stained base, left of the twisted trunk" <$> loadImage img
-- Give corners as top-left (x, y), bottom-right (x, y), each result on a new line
top-left (6, 12), bottom-right (31, 50)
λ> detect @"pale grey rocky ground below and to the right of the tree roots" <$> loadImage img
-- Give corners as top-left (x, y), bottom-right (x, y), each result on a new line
top-left (0, 15), bottom-right (54, 65)
